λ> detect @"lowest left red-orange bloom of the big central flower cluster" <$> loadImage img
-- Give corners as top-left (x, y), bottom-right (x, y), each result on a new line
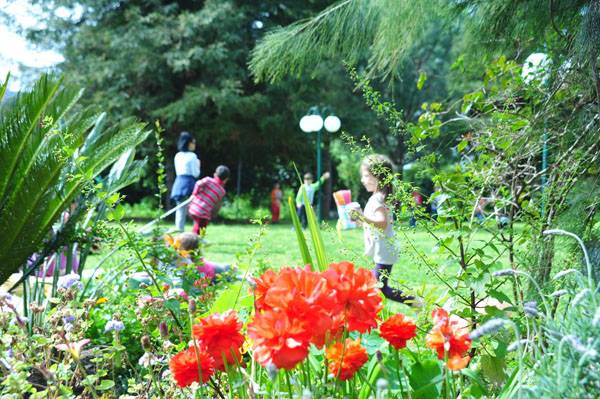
top-left (248, 310), bottom-right (310, 370)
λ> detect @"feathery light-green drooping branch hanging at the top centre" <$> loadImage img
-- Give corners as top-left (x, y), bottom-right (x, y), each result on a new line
top-left (250, 0), bottom-right (447, 82)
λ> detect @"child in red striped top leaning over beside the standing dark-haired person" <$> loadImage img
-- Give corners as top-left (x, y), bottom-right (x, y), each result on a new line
top-left (188, 165), bottom-right (230, 234)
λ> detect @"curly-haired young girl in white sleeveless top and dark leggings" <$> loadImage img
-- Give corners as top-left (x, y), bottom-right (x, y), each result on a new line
top-left (355, 154), bottom-right (418, 306)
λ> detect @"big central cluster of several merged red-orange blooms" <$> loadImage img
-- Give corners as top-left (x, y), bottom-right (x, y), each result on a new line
top-left (248, 262), bottom-right (382, 369)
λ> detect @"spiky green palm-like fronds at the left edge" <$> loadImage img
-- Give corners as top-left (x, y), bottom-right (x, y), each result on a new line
top-left (0, 75), bottom-right (149, 282)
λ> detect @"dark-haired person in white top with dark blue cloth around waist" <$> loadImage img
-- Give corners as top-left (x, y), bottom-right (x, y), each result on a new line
top-left (171, 132), bottom-right (200, 231)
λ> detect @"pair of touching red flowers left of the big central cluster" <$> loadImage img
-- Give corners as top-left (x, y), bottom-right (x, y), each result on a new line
top-left (169, 311), bottom-right (244, 387)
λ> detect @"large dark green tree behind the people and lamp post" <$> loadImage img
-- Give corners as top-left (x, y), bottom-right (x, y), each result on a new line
top-left (22, 0), bottom-right (384, 205)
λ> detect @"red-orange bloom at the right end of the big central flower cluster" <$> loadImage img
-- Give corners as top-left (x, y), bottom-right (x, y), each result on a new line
top-left (323, 262), bottom-right (383, 333)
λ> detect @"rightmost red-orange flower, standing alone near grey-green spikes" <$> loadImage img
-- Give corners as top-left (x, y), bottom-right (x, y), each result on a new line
top-left (425, 308), bottom-right (471, 370)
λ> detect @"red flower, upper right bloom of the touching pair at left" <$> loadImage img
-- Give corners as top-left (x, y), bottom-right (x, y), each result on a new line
top-left (192, 310), bottom-right (244, 371)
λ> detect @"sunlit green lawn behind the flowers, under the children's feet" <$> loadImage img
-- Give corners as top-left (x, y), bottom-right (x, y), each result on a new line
top-left (86, 222), bottom-right (510, 304)
